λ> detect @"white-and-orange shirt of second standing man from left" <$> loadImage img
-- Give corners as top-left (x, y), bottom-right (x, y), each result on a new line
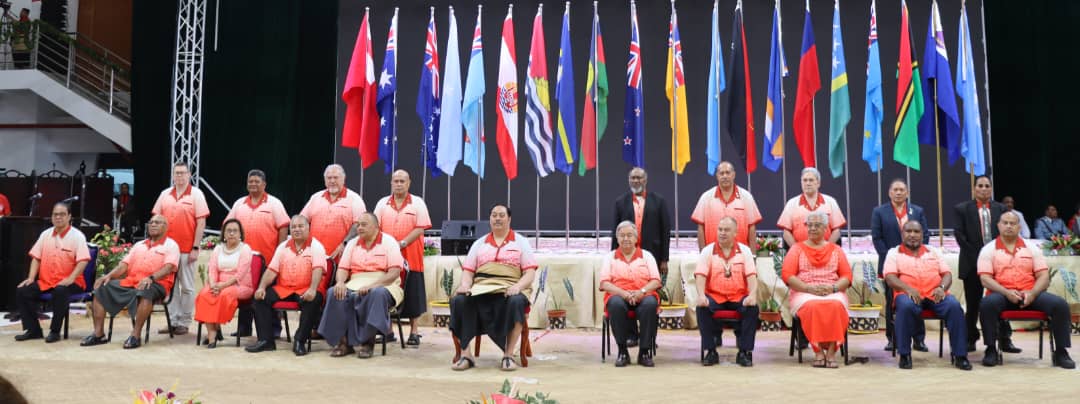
top-left (225, 193), bottom-right (288, 259)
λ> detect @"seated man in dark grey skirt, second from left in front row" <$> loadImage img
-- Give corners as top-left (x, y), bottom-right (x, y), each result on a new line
top-left (81, 215), bottom-right (180, 349)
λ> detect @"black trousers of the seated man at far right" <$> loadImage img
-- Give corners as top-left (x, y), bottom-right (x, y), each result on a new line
top-left (978, 292), bottom-right (1072, 349)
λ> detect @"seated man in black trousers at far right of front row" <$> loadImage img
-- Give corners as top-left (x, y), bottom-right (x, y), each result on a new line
top-left (978, 212), bottom-right (1076, 369)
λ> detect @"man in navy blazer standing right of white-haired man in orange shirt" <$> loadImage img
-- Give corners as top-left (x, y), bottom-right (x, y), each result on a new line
top-left (870, 178), bottom-right (930, 352)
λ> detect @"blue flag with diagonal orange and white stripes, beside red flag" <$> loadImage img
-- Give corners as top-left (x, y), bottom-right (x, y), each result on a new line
top-left (761, 1), bottom-right (787, 172)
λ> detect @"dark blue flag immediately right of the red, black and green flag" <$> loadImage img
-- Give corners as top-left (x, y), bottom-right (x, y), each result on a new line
top-left (919, 1), bottom-right (960, 164)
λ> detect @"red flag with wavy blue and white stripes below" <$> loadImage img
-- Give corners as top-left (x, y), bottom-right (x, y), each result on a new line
top-left (525, 4), bottom-right (555, 177)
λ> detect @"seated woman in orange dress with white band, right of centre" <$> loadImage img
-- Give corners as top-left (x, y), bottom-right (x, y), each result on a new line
top-left (782, 212), bottom-right (851, 368)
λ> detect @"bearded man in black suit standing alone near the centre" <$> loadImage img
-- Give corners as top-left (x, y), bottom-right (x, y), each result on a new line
top-left (611, 167), bottom-right (672, 347)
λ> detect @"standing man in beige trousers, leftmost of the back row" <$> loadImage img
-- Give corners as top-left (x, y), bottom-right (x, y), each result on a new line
top-left (151, 162), bottom-right (210, 335)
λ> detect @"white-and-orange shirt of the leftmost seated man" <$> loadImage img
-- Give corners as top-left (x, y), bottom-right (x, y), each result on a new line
top-left (30, 226), bottom-right (90, 291)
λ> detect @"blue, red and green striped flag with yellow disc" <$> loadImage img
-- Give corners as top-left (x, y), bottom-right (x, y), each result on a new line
top-left (578, 3), bottom-right (608, 175)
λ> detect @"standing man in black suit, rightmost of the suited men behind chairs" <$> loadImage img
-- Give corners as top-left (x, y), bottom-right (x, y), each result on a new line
top-left (954, 175), bottom-right (1021, 353)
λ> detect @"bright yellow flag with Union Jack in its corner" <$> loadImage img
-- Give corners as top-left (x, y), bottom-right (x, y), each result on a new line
top-left (664, 1), bottom-right (690, 174)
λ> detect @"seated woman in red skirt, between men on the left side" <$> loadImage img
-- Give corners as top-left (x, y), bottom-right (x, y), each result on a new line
top-left (195, 219), bottom-right (255, 348)
